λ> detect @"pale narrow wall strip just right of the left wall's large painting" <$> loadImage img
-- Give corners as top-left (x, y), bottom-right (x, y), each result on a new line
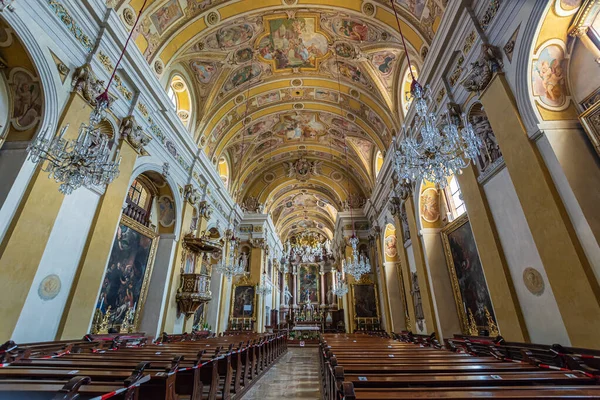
top-left (140, 234), bottom-right (177, 337)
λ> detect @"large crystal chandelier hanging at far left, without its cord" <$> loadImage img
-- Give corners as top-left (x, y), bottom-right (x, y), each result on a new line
top-left (27, 100), bottom-right (121, 195)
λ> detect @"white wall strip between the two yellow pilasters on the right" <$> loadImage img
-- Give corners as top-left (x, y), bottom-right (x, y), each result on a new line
top-left (484, 168), bottom-right (571, 345)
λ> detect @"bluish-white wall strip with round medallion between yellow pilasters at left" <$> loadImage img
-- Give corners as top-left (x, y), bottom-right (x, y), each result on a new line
top-left (12, 188), bottom-right (100, 343)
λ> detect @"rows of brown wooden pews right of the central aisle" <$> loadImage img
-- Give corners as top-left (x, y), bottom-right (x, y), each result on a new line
top-left (319, 333), bottom-right (600, 400)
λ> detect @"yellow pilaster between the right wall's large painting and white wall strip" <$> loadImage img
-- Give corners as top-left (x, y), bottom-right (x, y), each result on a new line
top-left (456, 165), bottom-right (529, 342)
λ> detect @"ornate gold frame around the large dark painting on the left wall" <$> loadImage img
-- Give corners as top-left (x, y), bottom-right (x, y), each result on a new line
top-left (91, 215), bottom-right (160, 333)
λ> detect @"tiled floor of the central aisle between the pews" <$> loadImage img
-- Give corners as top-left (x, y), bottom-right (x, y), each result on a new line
top-left (242, 347), bottom-right (321, 400)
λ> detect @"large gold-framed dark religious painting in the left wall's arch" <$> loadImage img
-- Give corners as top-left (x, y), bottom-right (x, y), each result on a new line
top-left (92, 216), bottom-right (158, 333)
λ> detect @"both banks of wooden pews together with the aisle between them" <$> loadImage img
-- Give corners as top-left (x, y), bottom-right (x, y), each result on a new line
top-left (0, 332), bottom-right (600, 400)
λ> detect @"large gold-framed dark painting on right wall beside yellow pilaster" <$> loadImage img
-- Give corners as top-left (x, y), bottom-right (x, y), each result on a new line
top-left (442, 214), bottom-right (499, 336)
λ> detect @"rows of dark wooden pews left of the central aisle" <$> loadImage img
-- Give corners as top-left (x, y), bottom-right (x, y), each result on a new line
top-left (0, 334), bottom-right (287, 400)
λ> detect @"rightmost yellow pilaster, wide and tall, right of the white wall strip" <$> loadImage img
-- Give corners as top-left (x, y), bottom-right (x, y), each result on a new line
top-left (479, 74), bottom-right (600, 348)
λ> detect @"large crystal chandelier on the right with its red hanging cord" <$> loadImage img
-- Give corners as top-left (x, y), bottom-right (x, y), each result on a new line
top-left (391, 0), bottom-right (482, 188)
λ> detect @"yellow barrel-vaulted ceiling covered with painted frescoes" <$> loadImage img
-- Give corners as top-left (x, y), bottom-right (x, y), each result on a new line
top-left (116, 0), bottom-right (447, 240)
